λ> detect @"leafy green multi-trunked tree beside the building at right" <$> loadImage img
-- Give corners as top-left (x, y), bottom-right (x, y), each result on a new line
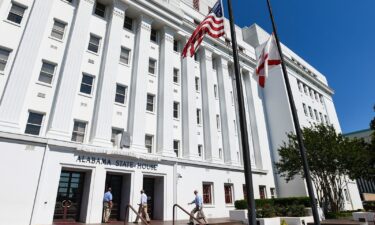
top-left (276, 124), bottom-right (370, 212)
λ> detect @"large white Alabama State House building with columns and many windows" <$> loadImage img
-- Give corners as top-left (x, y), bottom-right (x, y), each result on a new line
top-left (0, 0), bottom-right (362, 225)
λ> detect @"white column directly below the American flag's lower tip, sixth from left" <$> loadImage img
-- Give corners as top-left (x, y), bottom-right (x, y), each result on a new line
top-left (181, 44), bottom-right (200, 159)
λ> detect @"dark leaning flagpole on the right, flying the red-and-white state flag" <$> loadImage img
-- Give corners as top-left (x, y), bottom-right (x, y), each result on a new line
top-left (267, 0), bottom-right (320, 225)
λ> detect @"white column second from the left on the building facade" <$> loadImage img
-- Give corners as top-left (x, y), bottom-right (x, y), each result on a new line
top-left (47, 0), bottom-right (94, 140)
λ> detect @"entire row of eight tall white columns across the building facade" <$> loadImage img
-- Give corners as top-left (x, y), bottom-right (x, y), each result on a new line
top-left (0, 0), bottom-right (258, 163)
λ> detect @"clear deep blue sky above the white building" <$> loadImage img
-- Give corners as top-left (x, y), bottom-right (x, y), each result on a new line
top-left (223, 0), bottom-right (375, 133)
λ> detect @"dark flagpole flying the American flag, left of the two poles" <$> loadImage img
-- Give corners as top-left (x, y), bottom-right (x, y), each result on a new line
top-left (228, 0), bottom-right (256, 225)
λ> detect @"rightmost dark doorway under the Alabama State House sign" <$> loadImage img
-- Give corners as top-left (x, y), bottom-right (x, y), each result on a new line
top-left (143, 176), bottom-right (164, 220)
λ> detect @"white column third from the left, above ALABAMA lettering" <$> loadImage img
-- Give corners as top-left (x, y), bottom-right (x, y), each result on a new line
top-left (91, 0), bottom-right (126, 147)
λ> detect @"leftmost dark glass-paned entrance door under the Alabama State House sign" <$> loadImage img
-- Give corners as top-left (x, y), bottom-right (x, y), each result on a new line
top-left (53, 170), bottom-right (85, 222)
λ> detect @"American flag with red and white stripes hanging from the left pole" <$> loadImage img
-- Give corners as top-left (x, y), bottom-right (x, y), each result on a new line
top-left (182, 0), bottom-right (225, 57)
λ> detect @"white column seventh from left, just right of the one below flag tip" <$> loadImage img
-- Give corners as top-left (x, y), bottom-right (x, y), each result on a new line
top-left (200, 48), bottom-right (220, 162)
